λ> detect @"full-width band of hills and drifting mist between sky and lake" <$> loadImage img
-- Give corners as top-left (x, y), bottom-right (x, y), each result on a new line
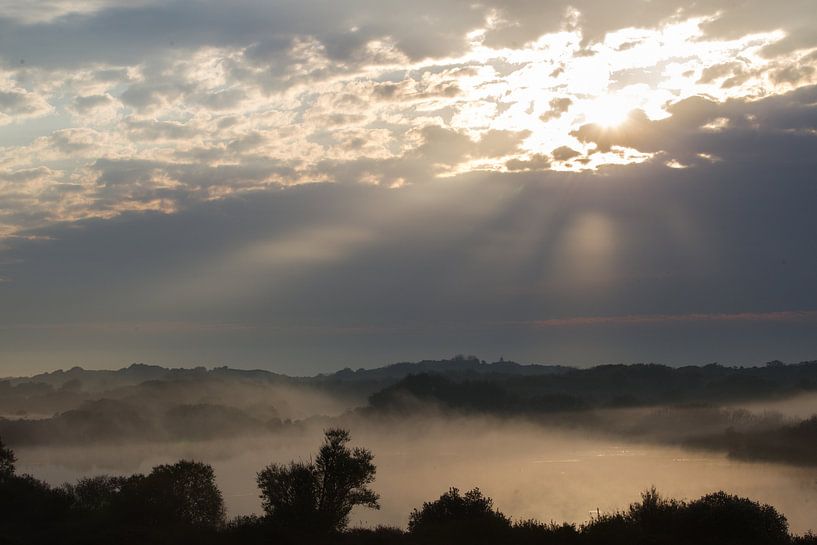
top-left (0, 357), bottom-right (817, 465)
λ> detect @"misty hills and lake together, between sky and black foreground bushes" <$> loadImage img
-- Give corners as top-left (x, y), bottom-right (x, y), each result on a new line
top-left (0, 356), bottom-right (817, 533)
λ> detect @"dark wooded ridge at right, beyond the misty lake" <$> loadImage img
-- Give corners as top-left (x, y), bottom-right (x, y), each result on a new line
top-left (370, 361), bottom-right (817, 414)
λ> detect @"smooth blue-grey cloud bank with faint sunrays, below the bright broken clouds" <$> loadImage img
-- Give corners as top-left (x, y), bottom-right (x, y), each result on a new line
top-left (0, 150), bottom-right (817, 369)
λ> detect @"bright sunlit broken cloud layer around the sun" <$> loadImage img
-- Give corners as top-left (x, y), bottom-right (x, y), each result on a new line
top-left (0, 1), bottom-right (817, 236)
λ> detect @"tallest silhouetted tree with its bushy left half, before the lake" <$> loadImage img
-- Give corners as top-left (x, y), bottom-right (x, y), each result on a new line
top-left (257, 429), bottom-right (380, 533)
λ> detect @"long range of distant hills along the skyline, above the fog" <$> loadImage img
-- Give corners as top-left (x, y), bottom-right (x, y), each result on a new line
top-left (6, 356), bottom-right (817, 418)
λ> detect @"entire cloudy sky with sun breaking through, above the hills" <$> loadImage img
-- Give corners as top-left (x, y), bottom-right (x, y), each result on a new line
top-left (0, 0), bottom-right (817, 375)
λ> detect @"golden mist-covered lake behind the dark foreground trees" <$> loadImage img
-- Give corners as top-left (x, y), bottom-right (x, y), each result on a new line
top-left (18, 414), bottom-right (817, 533)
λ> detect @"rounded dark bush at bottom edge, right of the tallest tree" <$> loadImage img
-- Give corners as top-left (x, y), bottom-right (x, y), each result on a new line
top-left (408, 488), bottom-right (511, 544)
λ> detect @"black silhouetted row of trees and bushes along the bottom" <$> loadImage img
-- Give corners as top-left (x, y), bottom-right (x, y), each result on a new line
top-left (0, 429), bottom-right (817, 545)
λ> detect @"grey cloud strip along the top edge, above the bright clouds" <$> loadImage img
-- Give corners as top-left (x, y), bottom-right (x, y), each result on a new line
top-left (0, 0), bottom-right (817, 73)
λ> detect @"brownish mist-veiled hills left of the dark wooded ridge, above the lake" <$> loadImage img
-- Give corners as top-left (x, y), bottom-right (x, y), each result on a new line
top-left (0, 373), bottom-right (365, 447)
